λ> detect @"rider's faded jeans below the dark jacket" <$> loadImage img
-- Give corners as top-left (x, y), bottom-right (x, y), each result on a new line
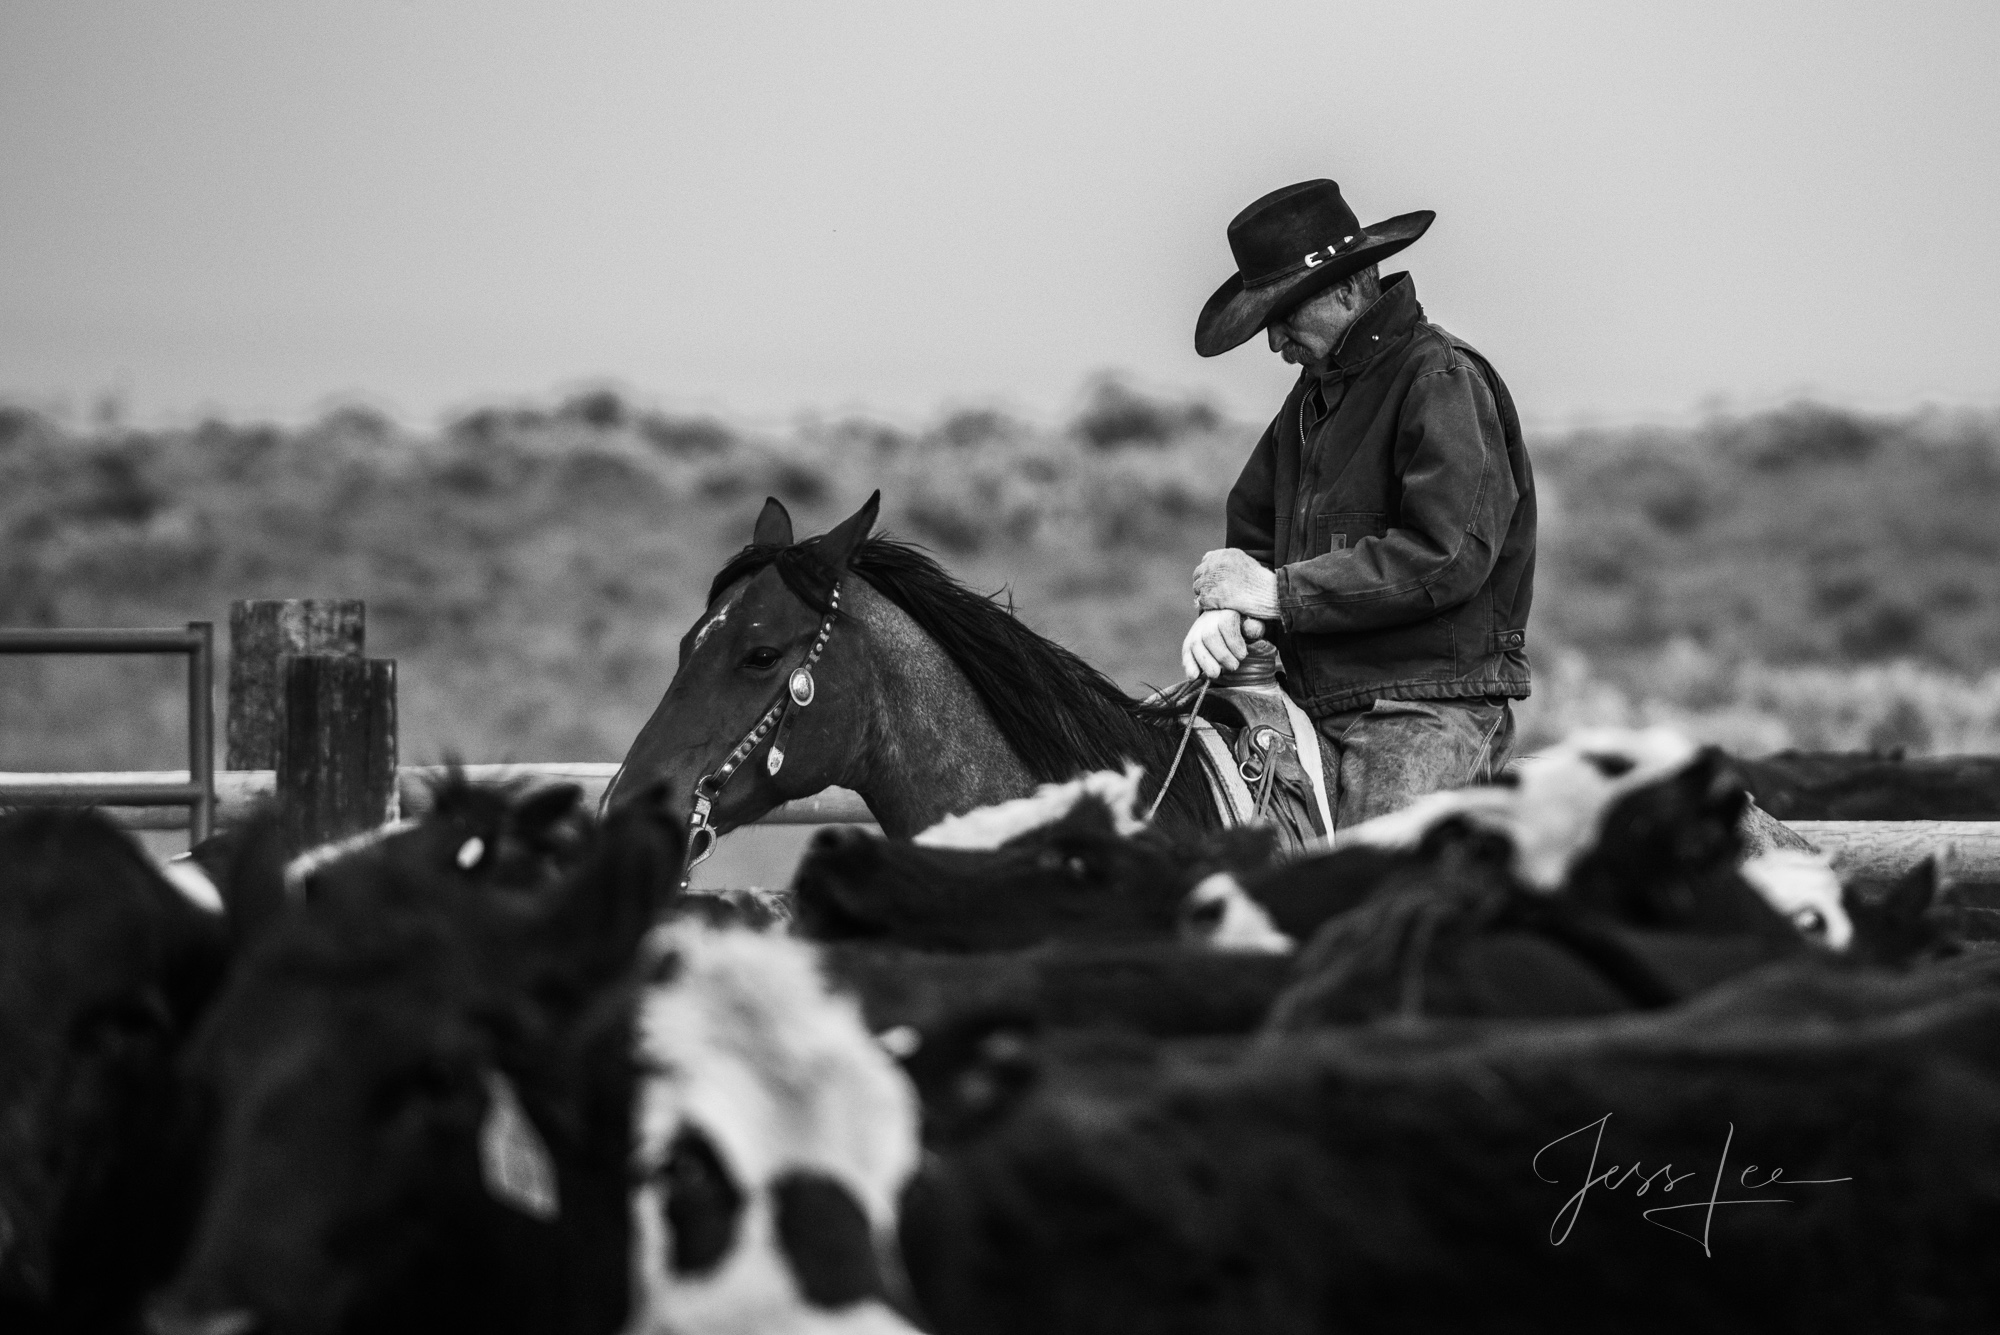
top-left (1318, 695), bottom-right (1514, 829)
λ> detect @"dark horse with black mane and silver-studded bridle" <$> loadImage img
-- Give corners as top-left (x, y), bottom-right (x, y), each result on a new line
top-left (604, 492), bottom-right (1222, 861)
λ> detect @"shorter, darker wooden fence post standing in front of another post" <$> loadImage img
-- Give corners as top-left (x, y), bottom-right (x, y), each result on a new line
top-left (276, 654), bottom-right (396, 851)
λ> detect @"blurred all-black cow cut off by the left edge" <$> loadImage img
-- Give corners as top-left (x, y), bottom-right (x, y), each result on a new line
top-left (0, 809), bottom-right (228, 1333)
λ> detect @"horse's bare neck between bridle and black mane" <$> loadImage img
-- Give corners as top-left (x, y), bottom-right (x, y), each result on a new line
top-left (848, 580), bottom-right (1036, 837)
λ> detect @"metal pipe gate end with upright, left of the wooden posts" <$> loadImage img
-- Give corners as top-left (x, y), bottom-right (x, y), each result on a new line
top-left (0, 622), bottom-right (216, 843)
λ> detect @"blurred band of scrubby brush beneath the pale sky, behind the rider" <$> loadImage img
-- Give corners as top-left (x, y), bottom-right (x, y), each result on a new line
top-left (0, 374), bottom-right (2000, 769)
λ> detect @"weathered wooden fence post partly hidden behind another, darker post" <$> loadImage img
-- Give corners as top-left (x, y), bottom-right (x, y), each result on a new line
top-left (222, 598), bottom-right (368, 769)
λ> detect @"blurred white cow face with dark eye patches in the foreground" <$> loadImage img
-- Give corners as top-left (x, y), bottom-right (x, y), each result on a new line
top-left (628, 923), bottom-right (918, 1335)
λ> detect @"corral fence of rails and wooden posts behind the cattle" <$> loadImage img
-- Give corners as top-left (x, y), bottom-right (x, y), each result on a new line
top-left (0, 600), bottom-right (2000, 885)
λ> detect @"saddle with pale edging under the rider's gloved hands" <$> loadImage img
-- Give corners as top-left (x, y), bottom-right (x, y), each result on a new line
top-left (1194, 640), bottom-right (1334, 853)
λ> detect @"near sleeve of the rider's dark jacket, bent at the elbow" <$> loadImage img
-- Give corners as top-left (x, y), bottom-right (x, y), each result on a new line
top-left (1280, 364), bottom-right (1520, 636)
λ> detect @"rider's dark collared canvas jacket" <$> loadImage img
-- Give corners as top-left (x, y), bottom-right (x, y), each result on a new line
top-left (1228, 274), bottom-right (1534, 717)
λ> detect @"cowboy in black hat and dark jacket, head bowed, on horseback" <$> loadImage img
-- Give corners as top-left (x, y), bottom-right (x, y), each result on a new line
top-left (1182, 180), bottom-right (1534, 827)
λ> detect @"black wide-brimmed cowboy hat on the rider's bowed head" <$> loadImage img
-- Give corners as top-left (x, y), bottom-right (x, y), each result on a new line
top-left (1194, 180), bottom-right (1436, 358)
